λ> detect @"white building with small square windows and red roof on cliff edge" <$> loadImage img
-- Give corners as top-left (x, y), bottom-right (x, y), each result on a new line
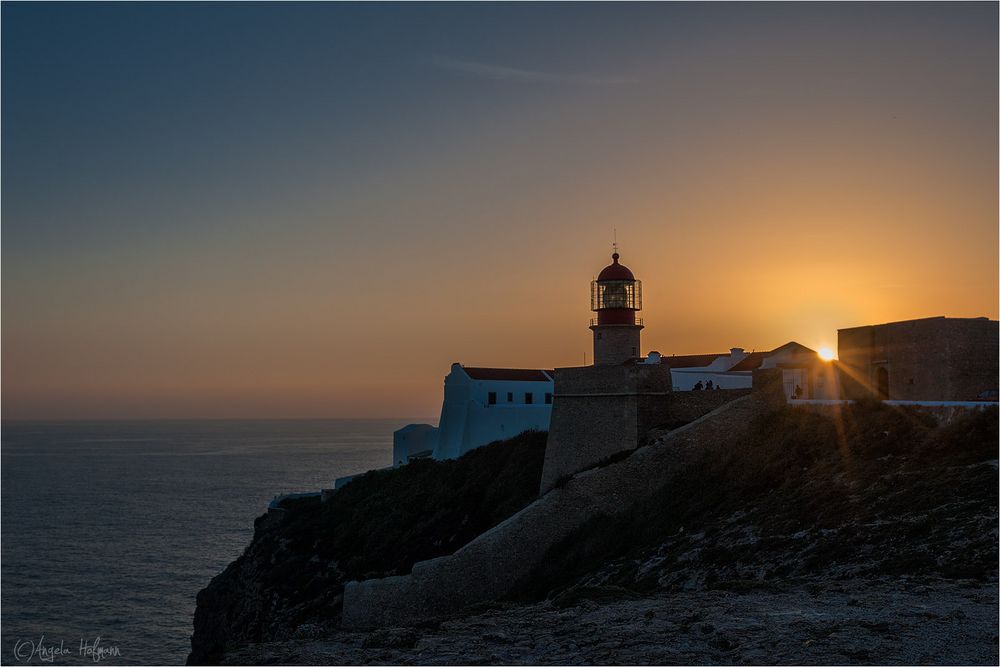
top-left (392, 363), bottom-right (554, 466)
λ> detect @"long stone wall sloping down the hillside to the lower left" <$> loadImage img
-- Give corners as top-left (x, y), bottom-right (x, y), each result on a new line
top-left (342, 395), bottom-right (760, 628)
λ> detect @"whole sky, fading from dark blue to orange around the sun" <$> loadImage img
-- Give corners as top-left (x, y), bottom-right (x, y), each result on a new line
top-left (0, 2), bottom-right (998, 419)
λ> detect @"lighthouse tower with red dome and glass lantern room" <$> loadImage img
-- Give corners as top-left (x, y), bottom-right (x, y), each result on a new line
top-left (590, 251), bottom-right (642, 366)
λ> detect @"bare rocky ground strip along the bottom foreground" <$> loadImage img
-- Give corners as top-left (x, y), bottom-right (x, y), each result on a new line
top-left (227, 578), bottom-right (998, 665)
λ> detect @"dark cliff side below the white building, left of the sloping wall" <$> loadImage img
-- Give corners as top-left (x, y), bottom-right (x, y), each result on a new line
top-left (188, 431), bottom-right (546, 664)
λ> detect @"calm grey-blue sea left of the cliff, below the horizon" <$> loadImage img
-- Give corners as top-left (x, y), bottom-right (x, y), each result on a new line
top-left (0, 419), bottom-right (418, 665)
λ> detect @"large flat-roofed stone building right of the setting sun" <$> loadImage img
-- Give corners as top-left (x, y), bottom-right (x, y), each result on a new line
top-left (838, 317), bottom-right (1000, 401)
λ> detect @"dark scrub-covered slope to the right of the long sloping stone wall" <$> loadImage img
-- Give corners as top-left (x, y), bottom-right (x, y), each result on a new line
top-left (515, 403), bottom-right (998, 602)
